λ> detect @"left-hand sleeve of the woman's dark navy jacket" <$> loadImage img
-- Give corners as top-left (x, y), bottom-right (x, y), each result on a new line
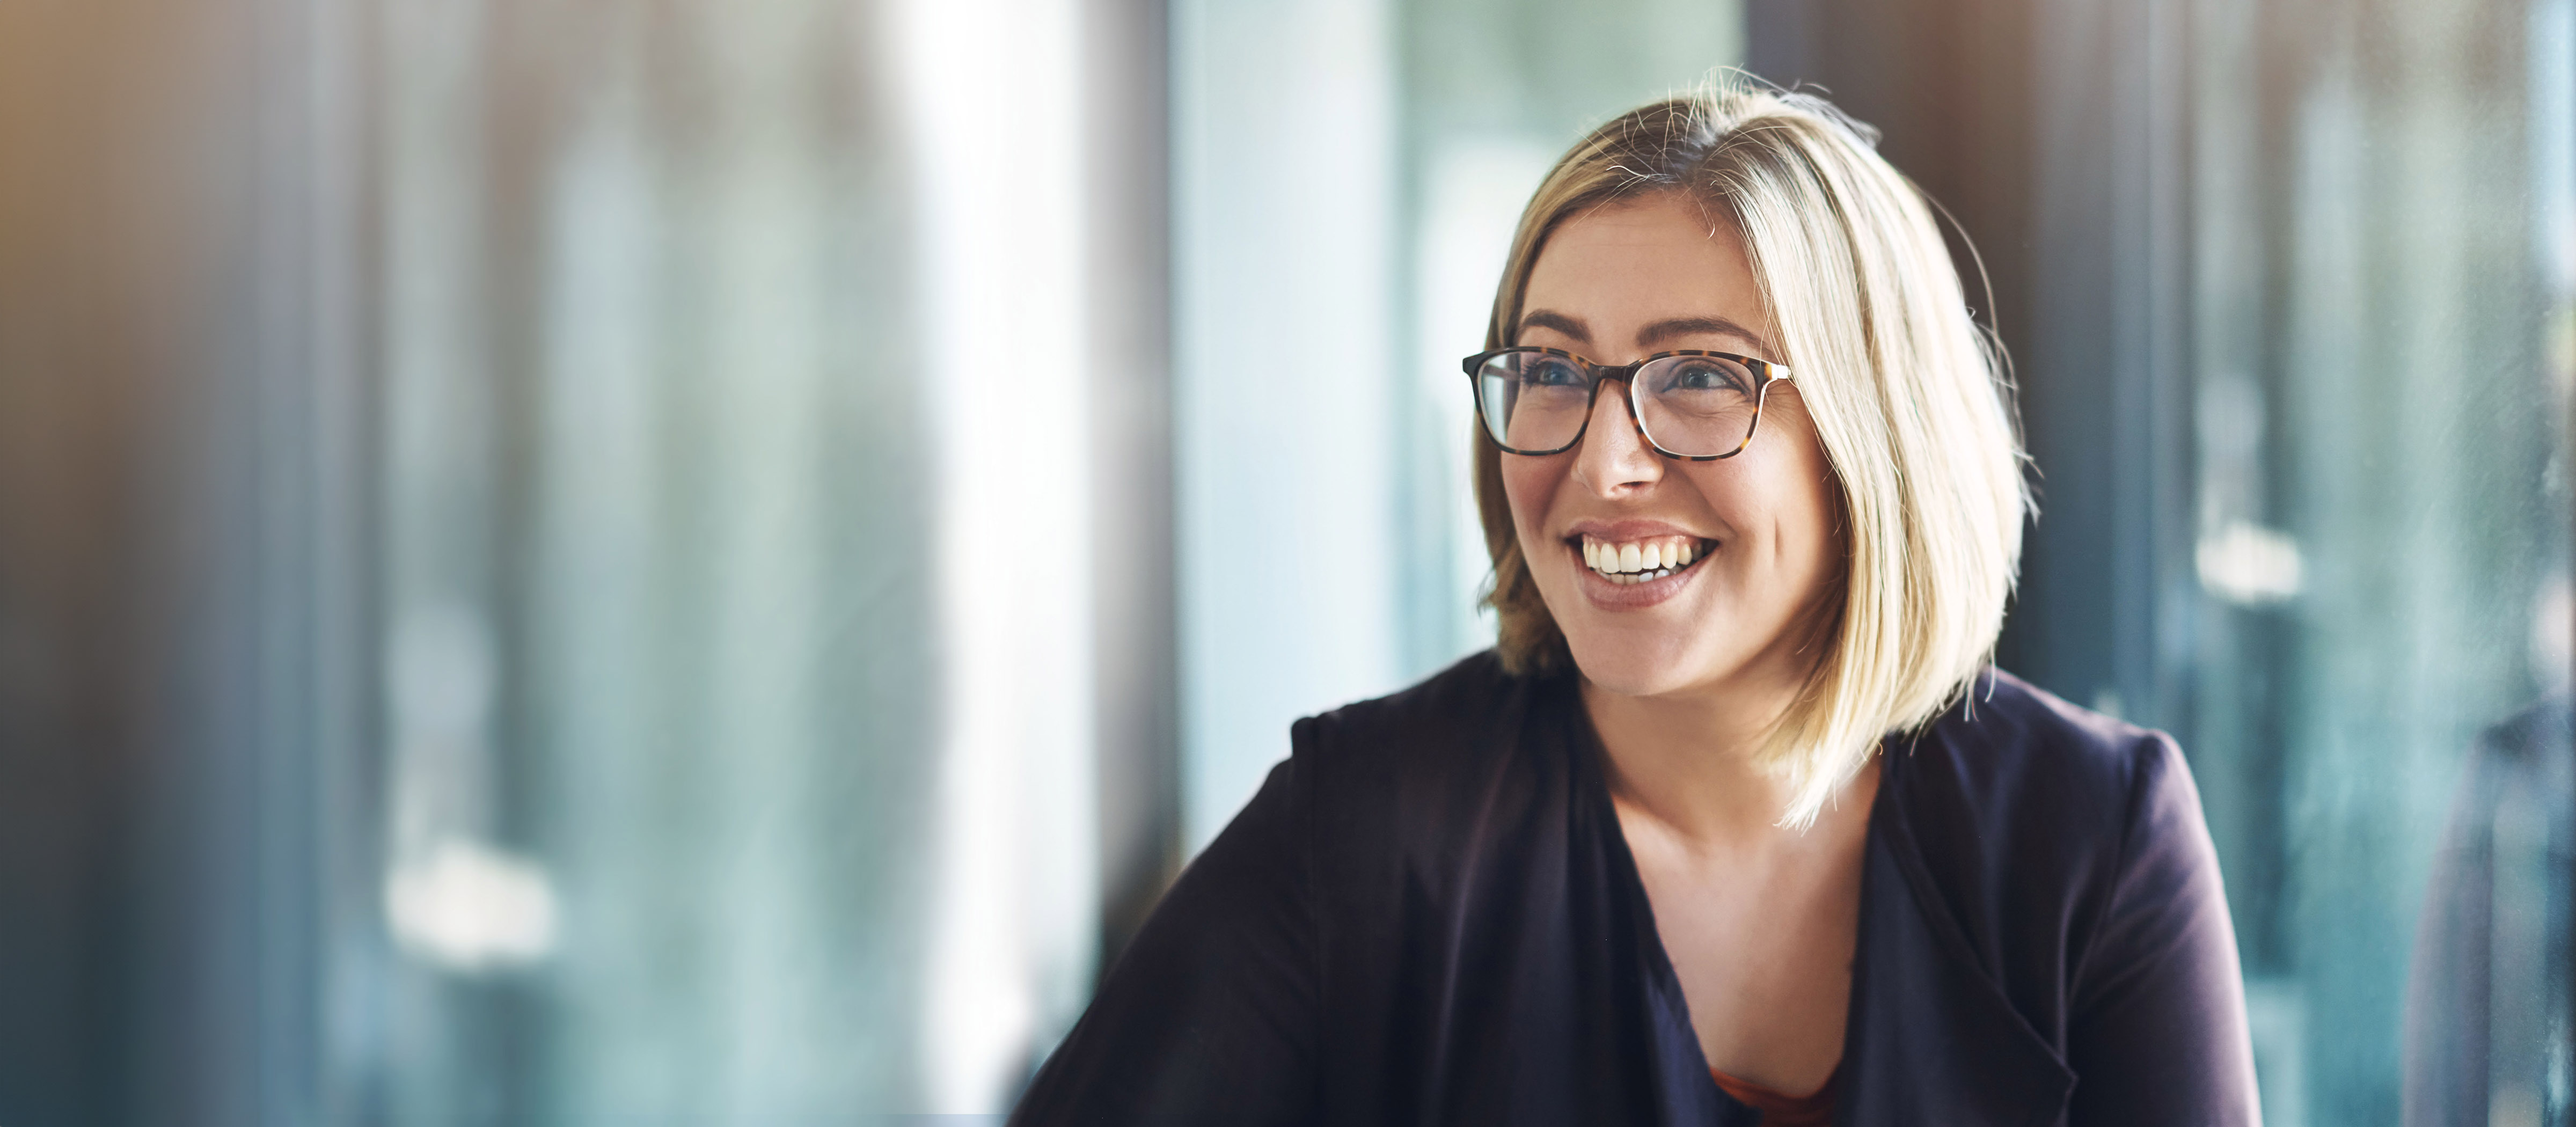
top-left (1010, 759), bottom-right (1316, 1127)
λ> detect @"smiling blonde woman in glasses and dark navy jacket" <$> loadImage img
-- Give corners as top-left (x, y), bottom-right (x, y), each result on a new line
top-left (1015, 87), bottom-right (2257, 1124)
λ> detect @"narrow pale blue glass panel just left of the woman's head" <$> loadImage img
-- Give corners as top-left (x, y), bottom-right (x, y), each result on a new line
top-left (1172, 0), bottom-right (1411, 852)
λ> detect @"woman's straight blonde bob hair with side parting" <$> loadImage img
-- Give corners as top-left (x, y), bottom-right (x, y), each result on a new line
top-left (1476, 75), bottom-right (2030, 826)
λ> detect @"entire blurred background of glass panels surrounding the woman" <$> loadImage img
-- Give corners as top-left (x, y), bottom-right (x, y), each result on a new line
top-left (0, 0), bottom-right (2576, 1127)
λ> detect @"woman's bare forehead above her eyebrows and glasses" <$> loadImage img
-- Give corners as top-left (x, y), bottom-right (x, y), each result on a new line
top-left (1520, 193), bottom-right (1775, 360)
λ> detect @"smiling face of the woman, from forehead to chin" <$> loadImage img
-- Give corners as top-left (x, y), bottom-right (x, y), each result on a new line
top-left (1502, 193), bottom-right (1842, 695)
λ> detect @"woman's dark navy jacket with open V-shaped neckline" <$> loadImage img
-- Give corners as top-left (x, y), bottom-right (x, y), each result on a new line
top-left (1012, 654), bottom-right (2259, 1127)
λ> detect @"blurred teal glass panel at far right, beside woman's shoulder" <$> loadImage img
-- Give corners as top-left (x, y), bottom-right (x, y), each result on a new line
top-left (2169, 0), bottom-right (2576, 1127)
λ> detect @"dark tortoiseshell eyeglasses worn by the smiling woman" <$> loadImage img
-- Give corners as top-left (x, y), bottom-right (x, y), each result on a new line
top-left (1461, 347), bottom-right (1788, 460)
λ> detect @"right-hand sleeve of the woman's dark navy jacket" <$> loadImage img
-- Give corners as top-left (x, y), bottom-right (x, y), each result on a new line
top-left (2066, 733), bottom-right (2262, 1127)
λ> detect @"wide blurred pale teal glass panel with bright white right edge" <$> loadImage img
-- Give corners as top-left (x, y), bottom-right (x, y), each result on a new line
top-left (361, 0), bottom-right (1097, 1124)
